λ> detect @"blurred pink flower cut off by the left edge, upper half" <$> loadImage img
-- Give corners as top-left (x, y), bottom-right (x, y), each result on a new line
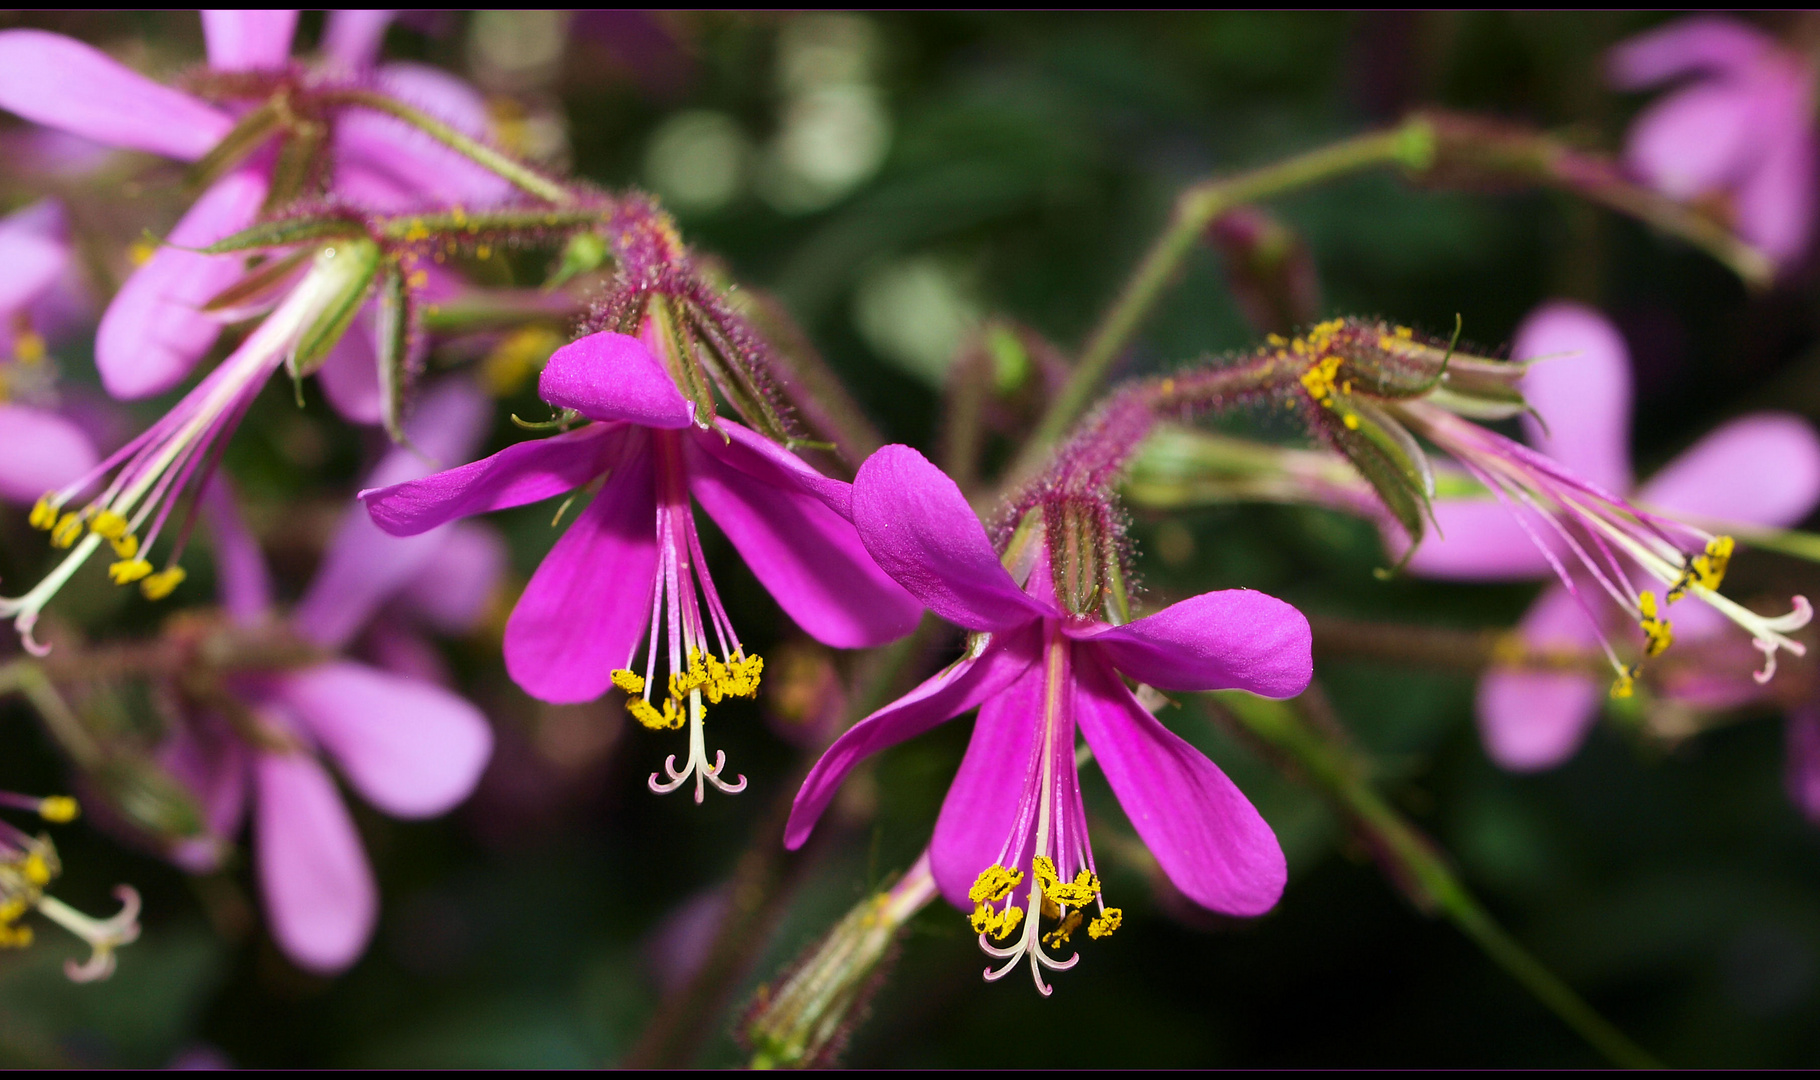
top-left (0, 200), bottom-right (96, 503)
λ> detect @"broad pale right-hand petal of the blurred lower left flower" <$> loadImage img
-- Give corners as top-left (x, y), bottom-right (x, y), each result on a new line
top-left (278, 661), bottom-right (493, 818)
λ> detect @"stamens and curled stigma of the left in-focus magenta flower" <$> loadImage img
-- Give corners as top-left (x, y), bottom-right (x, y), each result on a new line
top-left (613, 432), bottom-right (764, 803)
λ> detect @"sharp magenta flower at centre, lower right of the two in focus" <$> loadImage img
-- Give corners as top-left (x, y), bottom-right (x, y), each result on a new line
top-left (784, 446), bottom-right (1314, 994)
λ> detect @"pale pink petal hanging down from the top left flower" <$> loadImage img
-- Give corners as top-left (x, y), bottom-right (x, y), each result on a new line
top-left (95, 168), bottom-right (266, 399)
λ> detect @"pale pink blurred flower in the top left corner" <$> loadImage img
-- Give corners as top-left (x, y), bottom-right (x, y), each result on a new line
top-left (0, 11), bottom-right (510, 404)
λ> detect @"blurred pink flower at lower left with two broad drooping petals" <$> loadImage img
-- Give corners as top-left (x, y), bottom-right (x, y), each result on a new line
top-left (160, 384), bottom-right (493, 973)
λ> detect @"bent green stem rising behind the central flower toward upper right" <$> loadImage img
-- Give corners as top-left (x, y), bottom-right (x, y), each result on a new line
top-left (1014, 118), bottom-right (1432, 474)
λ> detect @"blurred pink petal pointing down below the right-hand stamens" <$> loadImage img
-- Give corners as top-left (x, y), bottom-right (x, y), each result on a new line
top-left (1478, 585), bottom-right (1605, 772)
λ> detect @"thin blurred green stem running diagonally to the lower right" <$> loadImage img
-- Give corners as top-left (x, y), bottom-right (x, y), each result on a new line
top-left (1203, 690), bottom-right (1662, 1069)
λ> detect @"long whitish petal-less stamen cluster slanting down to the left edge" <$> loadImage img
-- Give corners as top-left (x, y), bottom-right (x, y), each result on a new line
top-left (0, 246), bottom-right (371, 656)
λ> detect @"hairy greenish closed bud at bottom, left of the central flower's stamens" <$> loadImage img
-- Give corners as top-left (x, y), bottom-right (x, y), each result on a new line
top-left (739, 851), bottom-right (935, 1069)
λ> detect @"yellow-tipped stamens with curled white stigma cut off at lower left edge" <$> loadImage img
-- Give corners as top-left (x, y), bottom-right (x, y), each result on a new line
top-left (0, 792), bottom-right (140, 982)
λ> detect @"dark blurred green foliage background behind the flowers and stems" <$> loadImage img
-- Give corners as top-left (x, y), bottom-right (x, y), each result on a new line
top-left (0, 11), bottom-right (1820, 1067)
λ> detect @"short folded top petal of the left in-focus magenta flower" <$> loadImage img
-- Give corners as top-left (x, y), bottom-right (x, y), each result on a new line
top-left (537, 331), bottom-right (695, 428)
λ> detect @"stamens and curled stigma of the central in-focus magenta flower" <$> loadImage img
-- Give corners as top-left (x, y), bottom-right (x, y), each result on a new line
top-left (966, 634), bottom-right (1125, 996)
